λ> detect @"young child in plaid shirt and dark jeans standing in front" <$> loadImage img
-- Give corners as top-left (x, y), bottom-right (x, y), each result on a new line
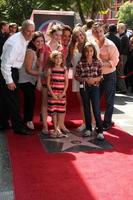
top-left (75, 42), bottom-right (104, 140)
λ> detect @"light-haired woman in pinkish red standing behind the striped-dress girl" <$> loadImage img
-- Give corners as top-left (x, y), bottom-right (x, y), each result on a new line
top-left (40, 25), bottom-right (62, 135)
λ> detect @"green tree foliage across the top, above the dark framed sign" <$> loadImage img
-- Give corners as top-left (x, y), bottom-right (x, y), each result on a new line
top-left (0, 0), bottom-right (112, 24)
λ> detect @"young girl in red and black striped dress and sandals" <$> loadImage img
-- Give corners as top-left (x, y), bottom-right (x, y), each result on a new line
top-left (47, 50), bottom-right (69, 138)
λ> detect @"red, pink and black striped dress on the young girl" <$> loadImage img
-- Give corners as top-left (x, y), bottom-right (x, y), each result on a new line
top-left (48, 67), bottom-right (66, 115)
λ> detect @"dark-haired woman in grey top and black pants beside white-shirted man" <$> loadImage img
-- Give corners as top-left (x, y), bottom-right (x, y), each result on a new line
top-left (19, 31), bottom-right (45, 129)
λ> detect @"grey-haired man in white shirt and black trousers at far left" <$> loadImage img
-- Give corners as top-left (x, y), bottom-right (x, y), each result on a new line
top-left (0, 20), bottom-right (35, 135)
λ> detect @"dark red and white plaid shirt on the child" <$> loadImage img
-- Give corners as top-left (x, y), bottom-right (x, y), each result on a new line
top-left (75, 60), bottom-right (102, 78)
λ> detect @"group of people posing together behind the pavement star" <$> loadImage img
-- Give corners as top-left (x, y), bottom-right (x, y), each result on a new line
top-left (0, 20), bottom-right (123, 140)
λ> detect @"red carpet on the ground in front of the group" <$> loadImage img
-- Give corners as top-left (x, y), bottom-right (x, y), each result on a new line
top-left (7, 127), bottom-right (133, 200)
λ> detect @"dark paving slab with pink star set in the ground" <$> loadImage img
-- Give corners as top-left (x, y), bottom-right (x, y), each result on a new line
top-left (41, 131), bottom-right (112, 152)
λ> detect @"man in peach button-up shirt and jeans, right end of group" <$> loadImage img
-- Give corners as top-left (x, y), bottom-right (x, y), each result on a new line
top-left (92, 23), bottom-right (119, 130)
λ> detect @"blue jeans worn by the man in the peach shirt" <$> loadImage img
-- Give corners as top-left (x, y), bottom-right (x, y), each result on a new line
top-left (100, 72), bottom-right (116, 125)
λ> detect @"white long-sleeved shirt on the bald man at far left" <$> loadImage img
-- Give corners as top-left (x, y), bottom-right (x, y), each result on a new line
top-left (1, 32), bottom-right (28, 84)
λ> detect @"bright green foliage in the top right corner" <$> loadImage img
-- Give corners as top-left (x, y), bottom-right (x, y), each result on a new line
top-left (117, 1), bottom-right (133, 29)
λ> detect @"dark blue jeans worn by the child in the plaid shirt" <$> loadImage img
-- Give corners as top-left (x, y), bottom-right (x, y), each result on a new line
top-left (80, 85), bottom-right (103, 133)
